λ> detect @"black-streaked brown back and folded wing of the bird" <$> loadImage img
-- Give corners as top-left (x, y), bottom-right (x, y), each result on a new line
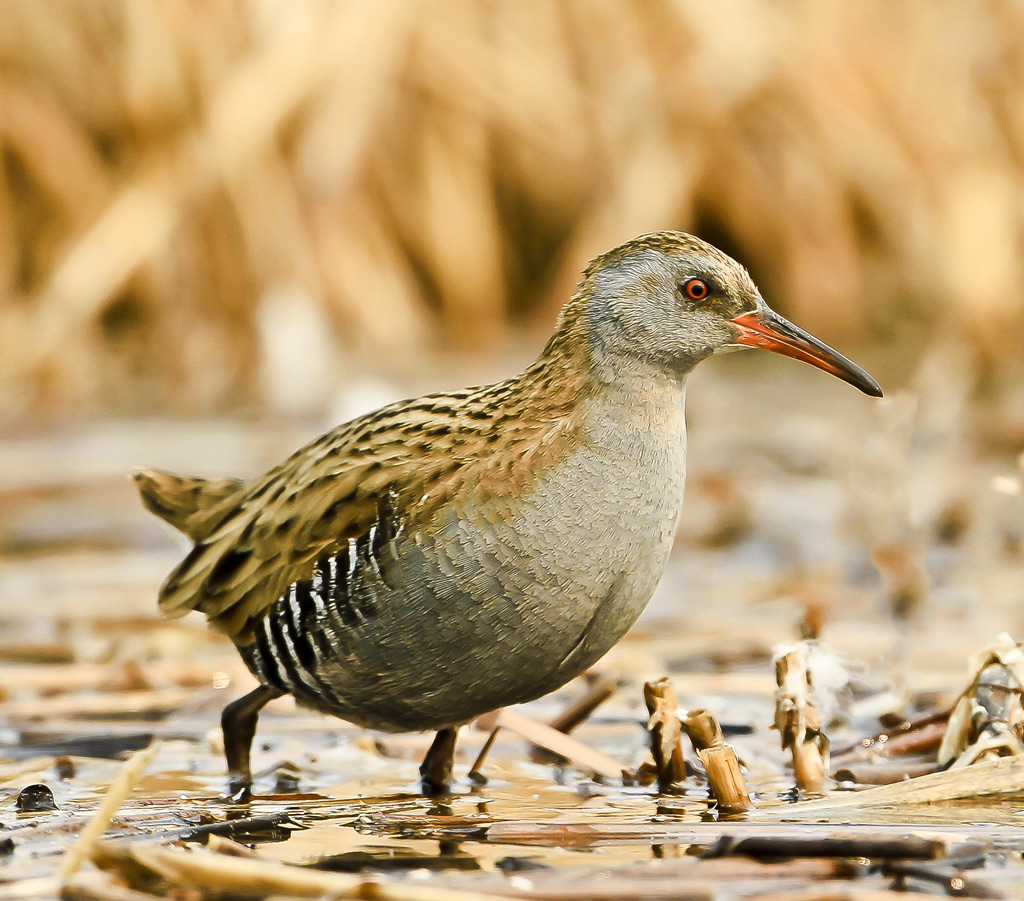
top-left (149, 362), bottom-right (583, 644)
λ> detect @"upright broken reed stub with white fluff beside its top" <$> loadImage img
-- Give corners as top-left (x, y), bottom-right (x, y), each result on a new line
top-left (775, 642), bottom-right (828, 792)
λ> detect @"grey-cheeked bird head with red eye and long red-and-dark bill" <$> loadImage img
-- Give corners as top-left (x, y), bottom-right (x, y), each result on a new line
top-left (580, 231), bottom-right (882, 397)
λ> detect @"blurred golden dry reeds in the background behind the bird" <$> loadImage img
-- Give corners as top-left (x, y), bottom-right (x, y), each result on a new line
top-left (0, 0), bottom-right (1024, 424)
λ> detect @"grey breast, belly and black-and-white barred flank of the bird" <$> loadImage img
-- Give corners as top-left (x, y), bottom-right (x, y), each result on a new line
top-left (243, 382), bottom-right (685, 731)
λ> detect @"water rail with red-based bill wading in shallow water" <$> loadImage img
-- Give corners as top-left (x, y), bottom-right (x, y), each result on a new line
top-left (135, 231), bottom-right (882, 799)
